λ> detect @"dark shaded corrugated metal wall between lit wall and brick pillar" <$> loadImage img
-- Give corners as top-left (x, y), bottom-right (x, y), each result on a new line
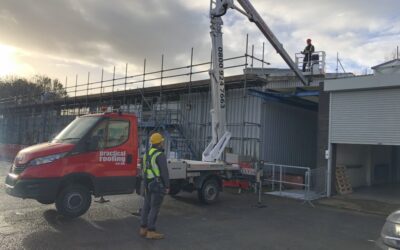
top-left (261, 102), bottom-right (318, 167)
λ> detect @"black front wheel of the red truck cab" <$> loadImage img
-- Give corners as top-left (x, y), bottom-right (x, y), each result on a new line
top-left (56, 184), bottom-right (92, 218)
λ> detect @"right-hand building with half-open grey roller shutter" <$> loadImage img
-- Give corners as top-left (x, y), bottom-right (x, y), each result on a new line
top-left (324, 59), bottom-right (400, 199)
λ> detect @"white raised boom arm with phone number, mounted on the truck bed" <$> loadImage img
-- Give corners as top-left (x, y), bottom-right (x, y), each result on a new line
top-left (203, 0), bottom-right (309, 162)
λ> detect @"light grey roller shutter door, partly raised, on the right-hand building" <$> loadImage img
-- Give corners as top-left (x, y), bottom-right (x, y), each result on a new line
top-left (330, 89), bottom-right (400, 145)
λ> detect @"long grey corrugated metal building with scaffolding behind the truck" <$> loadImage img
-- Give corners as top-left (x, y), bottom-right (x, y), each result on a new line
top-left (0, 47), bottom-right (334, 168)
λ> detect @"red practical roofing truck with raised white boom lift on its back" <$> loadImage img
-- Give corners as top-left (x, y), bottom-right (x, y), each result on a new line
top-left (5, 0), bottom-right (308, 218)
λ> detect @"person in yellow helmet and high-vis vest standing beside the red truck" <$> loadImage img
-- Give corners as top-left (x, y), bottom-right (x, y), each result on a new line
top-left (139, 133), bottom-right (169, 239)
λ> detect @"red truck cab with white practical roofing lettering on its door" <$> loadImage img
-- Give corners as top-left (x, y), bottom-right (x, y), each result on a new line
top-left (6, 113), bottom-right (138, 218)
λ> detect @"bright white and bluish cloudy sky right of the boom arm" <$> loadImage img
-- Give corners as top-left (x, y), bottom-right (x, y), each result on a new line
top-left (245, 0), bottom-right (400, 73)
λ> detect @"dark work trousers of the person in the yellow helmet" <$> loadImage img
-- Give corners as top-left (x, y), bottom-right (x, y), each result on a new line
top-left (141, 188), bottom-right (164, 231)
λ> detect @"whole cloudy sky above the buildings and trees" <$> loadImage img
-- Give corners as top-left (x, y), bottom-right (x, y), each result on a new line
top-left (0, 0), bottom-right (400, 87)
